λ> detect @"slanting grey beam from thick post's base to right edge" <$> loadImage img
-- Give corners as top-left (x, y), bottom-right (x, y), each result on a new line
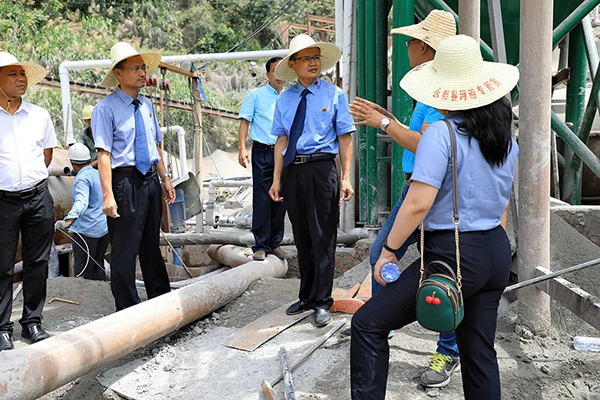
top-left (535, 267), bottom-right (600, 330)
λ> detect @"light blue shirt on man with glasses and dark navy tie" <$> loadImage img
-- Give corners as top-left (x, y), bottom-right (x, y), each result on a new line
top-left (273, 79), bottom-right (356, 154)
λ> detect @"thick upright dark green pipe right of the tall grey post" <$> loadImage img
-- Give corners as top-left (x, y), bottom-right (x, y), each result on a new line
top-left (562, 24), bottom-right (587, 204)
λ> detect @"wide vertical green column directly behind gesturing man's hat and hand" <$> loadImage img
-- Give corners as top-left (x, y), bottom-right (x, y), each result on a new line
top-left (390, 0), bottom-right (415, 208)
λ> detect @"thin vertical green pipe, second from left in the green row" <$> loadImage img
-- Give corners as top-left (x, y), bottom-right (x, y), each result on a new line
top-left (364, 0), bottom-right (382, 226)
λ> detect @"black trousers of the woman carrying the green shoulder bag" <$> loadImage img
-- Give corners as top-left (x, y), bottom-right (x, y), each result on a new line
top-left (350, 226), bottom-right (511, 400)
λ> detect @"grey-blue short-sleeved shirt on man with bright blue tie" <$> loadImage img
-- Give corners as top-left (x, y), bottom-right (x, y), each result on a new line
top-left (92, 88), bottom-right (162, 168)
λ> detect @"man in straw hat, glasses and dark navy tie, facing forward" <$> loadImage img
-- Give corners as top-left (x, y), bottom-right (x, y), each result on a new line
top-left (269, 35), bottom-right (356, 326)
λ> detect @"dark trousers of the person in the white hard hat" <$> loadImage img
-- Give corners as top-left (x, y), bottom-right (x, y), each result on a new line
top-left (71, 232), bottom-right (109, 281)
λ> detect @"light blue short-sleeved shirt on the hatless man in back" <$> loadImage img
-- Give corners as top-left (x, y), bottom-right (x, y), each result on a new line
top-left (238, 84), bottom-right (279, 145)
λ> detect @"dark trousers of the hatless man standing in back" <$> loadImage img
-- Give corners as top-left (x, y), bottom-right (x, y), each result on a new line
top-left (252, 146), bottom-right (285, 254)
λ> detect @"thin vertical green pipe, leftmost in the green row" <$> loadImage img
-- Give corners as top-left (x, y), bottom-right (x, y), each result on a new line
top-left (356, 0), bottom-right (368, 223)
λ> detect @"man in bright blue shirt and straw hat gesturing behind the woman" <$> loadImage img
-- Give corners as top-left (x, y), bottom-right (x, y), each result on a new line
top-left (350, 10), bottom-right (460, 387)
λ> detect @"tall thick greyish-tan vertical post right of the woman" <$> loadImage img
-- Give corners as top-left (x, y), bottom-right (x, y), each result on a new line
top-left (518, 0), bottom-right (553, 334)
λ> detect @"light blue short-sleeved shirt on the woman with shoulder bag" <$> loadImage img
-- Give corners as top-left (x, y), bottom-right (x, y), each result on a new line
top-left (412, 120), bottom-right (519, 232)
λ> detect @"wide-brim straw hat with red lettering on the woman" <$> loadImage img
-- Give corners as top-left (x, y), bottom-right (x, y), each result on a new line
top-left (400, 35), bottom-right (519, 110)
